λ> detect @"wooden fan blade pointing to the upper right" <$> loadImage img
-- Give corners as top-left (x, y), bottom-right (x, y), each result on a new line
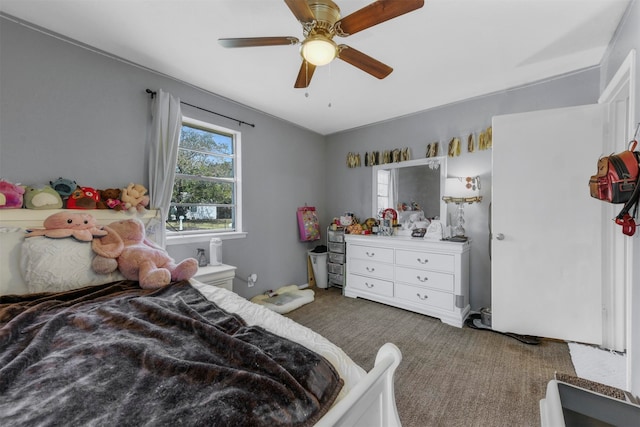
top-left (336, 0), bottom-right (424, 37)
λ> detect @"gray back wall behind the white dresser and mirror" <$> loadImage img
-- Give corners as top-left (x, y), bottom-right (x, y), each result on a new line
top-left (326, 69), bottom-right (599, 309)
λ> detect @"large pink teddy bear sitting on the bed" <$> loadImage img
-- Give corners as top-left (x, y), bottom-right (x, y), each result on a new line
top-left (92, 218), bottom-right (198, 289)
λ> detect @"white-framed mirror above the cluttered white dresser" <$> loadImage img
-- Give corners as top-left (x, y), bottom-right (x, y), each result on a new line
top-left (372, 156), bottom-right (447, 225)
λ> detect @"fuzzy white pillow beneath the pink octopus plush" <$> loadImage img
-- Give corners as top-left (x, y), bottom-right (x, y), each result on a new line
top-left (20, 237), bottom-right (124, 293)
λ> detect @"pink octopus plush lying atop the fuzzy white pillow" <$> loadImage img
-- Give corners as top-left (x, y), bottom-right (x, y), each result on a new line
top-left (25, 212), bottom-right (107, 242)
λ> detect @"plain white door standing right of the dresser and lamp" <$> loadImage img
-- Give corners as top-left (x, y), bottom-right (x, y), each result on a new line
top-left (491, 105), bottom-right (605, 344)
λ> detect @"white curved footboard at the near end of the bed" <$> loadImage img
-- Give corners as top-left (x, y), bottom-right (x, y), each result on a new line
top-left (316, 343), bottom-right (402, 427)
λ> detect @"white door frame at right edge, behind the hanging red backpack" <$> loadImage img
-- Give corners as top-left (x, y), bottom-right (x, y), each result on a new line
top-left (598, 50), bottom-right (640, 390)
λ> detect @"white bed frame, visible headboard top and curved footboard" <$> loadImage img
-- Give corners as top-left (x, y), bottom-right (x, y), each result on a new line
top-left (0, 209), bottom-right (402, 427)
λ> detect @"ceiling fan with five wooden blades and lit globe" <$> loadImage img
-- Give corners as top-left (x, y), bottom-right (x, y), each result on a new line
top-left (218, 0), bottom-right (424, 88)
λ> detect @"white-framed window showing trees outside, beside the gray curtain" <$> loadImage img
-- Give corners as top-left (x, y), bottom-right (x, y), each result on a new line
top-left (166, 117), bottom-right (242, 236)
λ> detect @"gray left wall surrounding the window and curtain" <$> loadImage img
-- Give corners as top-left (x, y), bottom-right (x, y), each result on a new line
top-left (0, 18), bottom-right (325, 296)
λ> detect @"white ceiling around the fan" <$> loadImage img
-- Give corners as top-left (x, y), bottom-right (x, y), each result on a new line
top-left (0, 0), bottom-right (630, 135)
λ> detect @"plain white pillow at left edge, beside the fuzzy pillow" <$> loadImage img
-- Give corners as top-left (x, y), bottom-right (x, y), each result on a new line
top-left (0, 227), bottom-right (29, 295)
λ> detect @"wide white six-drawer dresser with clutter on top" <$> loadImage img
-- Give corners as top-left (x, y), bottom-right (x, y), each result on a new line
top-left (344, 234), bottom-right (470, 327)
